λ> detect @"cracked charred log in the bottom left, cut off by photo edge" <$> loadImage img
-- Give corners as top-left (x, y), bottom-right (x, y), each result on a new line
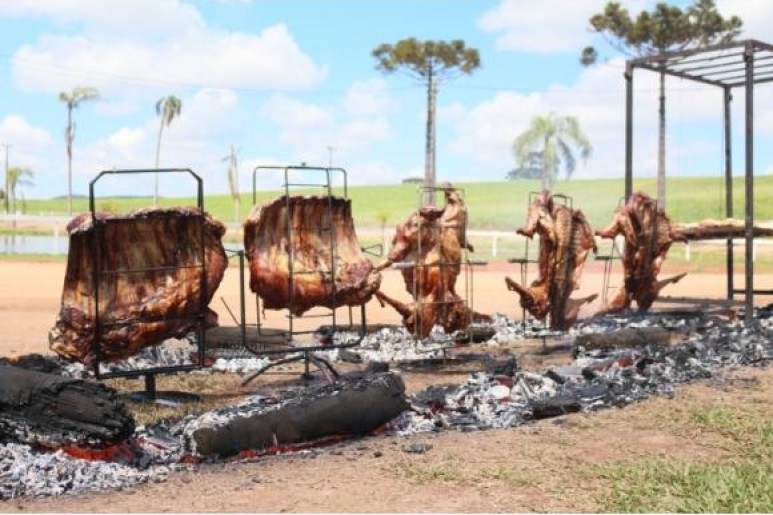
top-left (0, 366), bottom-right (134, 447)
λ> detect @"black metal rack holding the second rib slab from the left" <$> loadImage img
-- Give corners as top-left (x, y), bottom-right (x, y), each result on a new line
top-left (241, 165), bottom-right (367, 385)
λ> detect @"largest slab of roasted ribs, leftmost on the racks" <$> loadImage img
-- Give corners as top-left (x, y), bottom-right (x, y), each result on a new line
top-left (49, 207), bottom-right (227, 365)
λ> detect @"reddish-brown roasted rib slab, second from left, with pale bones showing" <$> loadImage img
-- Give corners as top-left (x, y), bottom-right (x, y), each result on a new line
top-left (244, 196), bottom-right (381, 316)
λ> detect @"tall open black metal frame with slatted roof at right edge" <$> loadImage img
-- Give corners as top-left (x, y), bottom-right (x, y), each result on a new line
top-left (625, 39), bottom-right (773, 325)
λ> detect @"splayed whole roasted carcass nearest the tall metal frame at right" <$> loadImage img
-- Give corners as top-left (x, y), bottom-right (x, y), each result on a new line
top-left (596, 192), bottom-right (687, 312)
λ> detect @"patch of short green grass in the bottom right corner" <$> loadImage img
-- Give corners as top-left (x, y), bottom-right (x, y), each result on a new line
top-left (597, 405), bottom-right (773, 513)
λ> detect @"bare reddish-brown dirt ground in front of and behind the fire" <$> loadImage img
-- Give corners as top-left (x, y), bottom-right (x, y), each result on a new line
top-left (0, 260), bottom-right (773, 513)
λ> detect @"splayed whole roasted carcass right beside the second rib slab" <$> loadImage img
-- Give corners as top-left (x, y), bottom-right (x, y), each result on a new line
top-left (376, 184), bottom-right (489, 339)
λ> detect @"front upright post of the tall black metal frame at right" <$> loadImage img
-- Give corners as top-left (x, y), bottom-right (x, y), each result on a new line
top-left (744, 45), bottom-right (754, 325)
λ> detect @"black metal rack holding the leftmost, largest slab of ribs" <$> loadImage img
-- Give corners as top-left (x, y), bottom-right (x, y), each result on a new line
top-left (89, 168), bottom-right (208, 400)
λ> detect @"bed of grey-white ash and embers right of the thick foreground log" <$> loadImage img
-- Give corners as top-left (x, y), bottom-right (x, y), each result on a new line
top-left (393, 309), bottom-right (773, 433)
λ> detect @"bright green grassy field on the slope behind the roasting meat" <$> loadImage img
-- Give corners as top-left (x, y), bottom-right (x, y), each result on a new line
top-left (19, 176), bottom-right (773, 231)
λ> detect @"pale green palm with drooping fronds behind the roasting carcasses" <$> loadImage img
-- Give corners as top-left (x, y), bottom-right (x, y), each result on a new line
top-left (513, 112), bottom-right (593, 190)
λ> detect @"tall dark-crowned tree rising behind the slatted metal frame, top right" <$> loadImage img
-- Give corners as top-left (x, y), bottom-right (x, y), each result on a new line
top-left (580, 0), bottom-right (743, 208)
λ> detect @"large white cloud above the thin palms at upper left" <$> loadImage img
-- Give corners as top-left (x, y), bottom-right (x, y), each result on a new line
top-left (9, 0), bottom-right (327, 95)
